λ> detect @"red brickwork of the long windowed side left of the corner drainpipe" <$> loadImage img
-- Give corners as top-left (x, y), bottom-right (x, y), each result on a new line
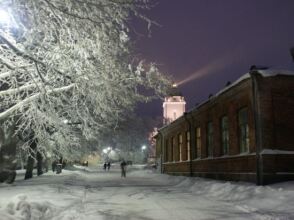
top-left (164, 79), bottom-right (256, 181)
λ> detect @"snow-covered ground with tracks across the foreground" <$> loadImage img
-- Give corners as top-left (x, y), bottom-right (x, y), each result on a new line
top-left (0, 166), bottom-right (294, 220)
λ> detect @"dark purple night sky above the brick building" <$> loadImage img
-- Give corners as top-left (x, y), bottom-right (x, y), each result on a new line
top-left (133, 0), bottom-right (294, 116)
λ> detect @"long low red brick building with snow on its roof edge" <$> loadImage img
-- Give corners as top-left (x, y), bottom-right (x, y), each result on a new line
top-left (156, 70), bottom-right (294, 185)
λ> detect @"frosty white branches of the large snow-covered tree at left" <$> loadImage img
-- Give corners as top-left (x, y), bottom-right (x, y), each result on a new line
top-left (0, 0), bottom-right (169, 165)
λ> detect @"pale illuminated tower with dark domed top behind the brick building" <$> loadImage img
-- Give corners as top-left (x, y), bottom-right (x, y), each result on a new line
top-left (163, 84), bottom-right (186, 125)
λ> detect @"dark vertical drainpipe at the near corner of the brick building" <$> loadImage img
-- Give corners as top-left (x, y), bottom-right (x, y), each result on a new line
top-left (249, 70), bottom-right (263, 185)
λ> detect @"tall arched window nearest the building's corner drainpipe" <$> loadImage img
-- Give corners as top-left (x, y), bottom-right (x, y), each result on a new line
top-left (238, 108), bottom-right (249, 153)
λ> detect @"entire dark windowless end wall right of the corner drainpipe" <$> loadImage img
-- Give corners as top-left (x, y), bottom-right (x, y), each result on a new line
top-left (254, 75), bottom-right (294, 184)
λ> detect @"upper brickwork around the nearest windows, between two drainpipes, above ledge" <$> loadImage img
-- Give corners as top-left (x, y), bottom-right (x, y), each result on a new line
top-left (192, 79), bottom-right (255, 158)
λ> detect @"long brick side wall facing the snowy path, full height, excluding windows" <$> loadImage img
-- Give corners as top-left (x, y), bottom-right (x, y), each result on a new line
top-left (160, 79), bottom-right (256, 181)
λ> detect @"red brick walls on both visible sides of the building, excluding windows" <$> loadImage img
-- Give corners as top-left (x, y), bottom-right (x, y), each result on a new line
top-left (158, 73), bottom-right (294, 184)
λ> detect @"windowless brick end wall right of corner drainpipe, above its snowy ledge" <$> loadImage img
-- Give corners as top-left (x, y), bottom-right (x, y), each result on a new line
top-left (258, 76), bottom-right (294, 151)
